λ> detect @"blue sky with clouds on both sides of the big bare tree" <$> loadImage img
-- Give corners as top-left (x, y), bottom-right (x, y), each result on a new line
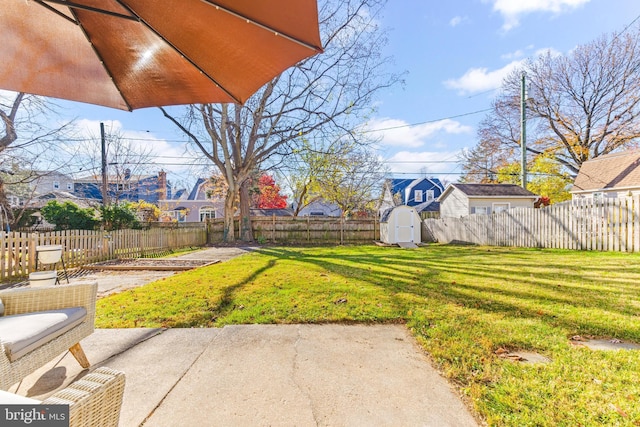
top-left (52, 0), bottom-right (640, 191)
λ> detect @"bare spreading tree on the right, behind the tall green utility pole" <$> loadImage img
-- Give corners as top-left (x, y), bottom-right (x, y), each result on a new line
top-left (468, 28), bottom-right (640, 175)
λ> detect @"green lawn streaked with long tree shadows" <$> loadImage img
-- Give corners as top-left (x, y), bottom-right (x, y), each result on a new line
top-left (96, 245), bottom-right (640, 426)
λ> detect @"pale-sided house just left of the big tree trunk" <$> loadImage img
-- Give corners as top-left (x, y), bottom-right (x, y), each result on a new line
top-left (158, 178), bottom-right (224, 222)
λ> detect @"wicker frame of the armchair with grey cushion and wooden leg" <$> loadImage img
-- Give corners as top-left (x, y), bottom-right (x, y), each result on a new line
top-left (0, 283), bottom-right (98, 390)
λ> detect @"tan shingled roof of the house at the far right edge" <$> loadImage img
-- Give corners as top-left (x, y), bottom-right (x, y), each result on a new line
top-left (571, 150), bottom-right (640, 193)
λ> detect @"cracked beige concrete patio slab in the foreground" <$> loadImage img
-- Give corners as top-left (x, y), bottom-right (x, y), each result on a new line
top-left (11, 325), bottom-right (477, 427)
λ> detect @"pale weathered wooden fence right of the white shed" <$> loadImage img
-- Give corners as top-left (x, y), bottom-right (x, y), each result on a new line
top-left (423, 196), bottom-right (640, 252)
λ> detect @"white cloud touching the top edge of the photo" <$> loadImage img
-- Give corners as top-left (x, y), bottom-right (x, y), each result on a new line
top-left (490, 0), bottom-right (590, 31)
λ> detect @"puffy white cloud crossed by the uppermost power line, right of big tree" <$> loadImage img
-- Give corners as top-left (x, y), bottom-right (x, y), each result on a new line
top-left (368, 119), bottom-right (473, 148)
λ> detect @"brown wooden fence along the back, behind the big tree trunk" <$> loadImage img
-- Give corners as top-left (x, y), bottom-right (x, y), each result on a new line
top-left (208, 216), bottom-right (380, 244)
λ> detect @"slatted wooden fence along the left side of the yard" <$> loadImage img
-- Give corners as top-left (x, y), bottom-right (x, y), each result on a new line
top-left (0, 226), bottom-right (207, 280)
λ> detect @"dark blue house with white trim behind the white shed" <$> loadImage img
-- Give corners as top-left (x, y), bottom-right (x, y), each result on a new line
top-left (380, 178), bottom-right (444, 213)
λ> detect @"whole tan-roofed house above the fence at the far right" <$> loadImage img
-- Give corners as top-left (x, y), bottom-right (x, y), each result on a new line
top-left (571, 150), bottom-right (640, 200)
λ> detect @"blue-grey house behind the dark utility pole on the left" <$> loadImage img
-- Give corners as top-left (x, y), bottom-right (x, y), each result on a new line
top-left (73, 170), bottom-right (171, 205)
